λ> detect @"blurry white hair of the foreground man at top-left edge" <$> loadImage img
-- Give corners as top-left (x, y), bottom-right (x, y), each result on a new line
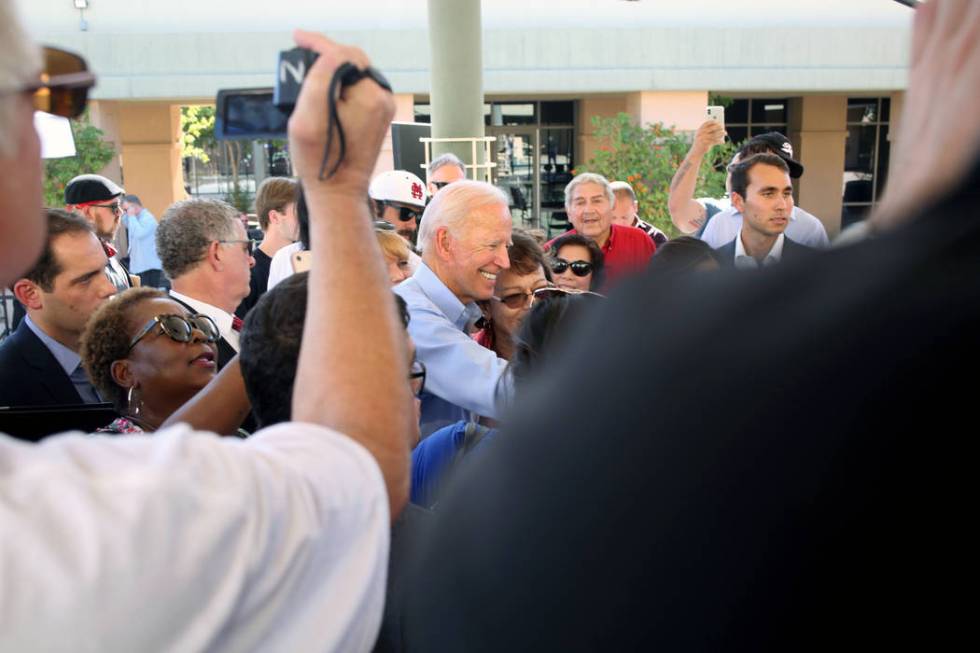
top-left (0, 0), bottom-right (41, 157)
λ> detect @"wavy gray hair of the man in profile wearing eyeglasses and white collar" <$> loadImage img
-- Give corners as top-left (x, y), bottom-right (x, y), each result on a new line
top-left (157, 199), bottom-right (241, 279)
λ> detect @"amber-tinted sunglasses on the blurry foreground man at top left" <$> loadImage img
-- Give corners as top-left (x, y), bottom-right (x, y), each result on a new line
top-left (6, 48), bottom-right (95, 118)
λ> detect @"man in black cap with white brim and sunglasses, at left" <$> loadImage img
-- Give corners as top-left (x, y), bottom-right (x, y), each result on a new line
top-left (65, 175), bottom-right (133, 291)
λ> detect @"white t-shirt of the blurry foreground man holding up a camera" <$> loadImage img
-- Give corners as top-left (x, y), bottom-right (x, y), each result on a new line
top-left (0, 423), bottom-right (389, 653)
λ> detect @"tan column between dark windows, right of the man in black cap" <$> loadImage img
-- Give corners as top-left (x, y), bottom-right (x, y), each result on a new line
top-left (787, 95), bottom-right (847, 238)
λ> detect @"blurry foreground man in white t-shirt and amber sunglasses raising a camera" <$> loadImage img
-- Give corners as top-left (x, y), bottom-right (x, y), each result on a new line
top-left (0, 0), bottom-right (413, 653)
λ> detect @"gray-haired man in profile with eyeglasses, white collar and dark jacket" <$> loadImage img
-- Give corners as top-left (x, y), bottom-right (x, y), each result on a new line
top-left (157, 199), bottom-right (255, 369)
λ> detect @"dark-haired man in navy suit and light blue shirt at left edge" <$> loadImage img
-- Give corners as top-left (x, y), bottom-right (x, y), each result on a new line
top-left (0, 209), bottom-right (115, 406)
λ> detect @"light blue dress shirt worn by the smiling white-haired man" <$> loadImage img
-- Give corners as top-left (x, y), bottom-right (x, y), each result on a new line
top-left (395, 263), bottom-right (511, 436)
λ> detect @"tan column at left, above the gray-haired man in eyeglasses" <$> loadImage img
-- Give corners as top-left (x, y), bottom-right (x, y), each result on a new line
top-left (118, 102), bottom-right (186, 217)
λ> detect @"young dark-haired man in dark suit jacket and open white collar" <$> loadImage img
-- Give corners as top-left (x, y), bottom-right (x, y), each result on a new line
top-left (715, 154), bottom-right (814, 270)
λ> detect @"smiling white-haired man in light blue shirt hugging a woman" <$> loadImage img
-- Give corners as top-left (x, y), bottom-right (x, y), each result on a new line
top-left (395, 181), bottom-right (512, 436)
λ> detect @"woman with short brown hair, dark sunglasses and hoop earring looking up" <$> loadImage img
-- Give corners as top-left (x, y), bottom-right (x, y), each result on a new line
top-left (80, 288), bottom-right (220, 433)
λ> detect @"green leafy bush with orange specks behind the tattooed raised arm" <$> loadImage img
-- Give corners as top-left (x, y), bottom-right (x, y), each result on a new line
top-left (574, 113), bottom-right (735, 236)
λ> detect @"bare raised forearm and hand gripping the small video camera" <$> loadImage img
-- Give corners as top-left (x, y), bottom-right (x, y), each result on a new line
top-left (289, 31), bottom-right (414, 518)
